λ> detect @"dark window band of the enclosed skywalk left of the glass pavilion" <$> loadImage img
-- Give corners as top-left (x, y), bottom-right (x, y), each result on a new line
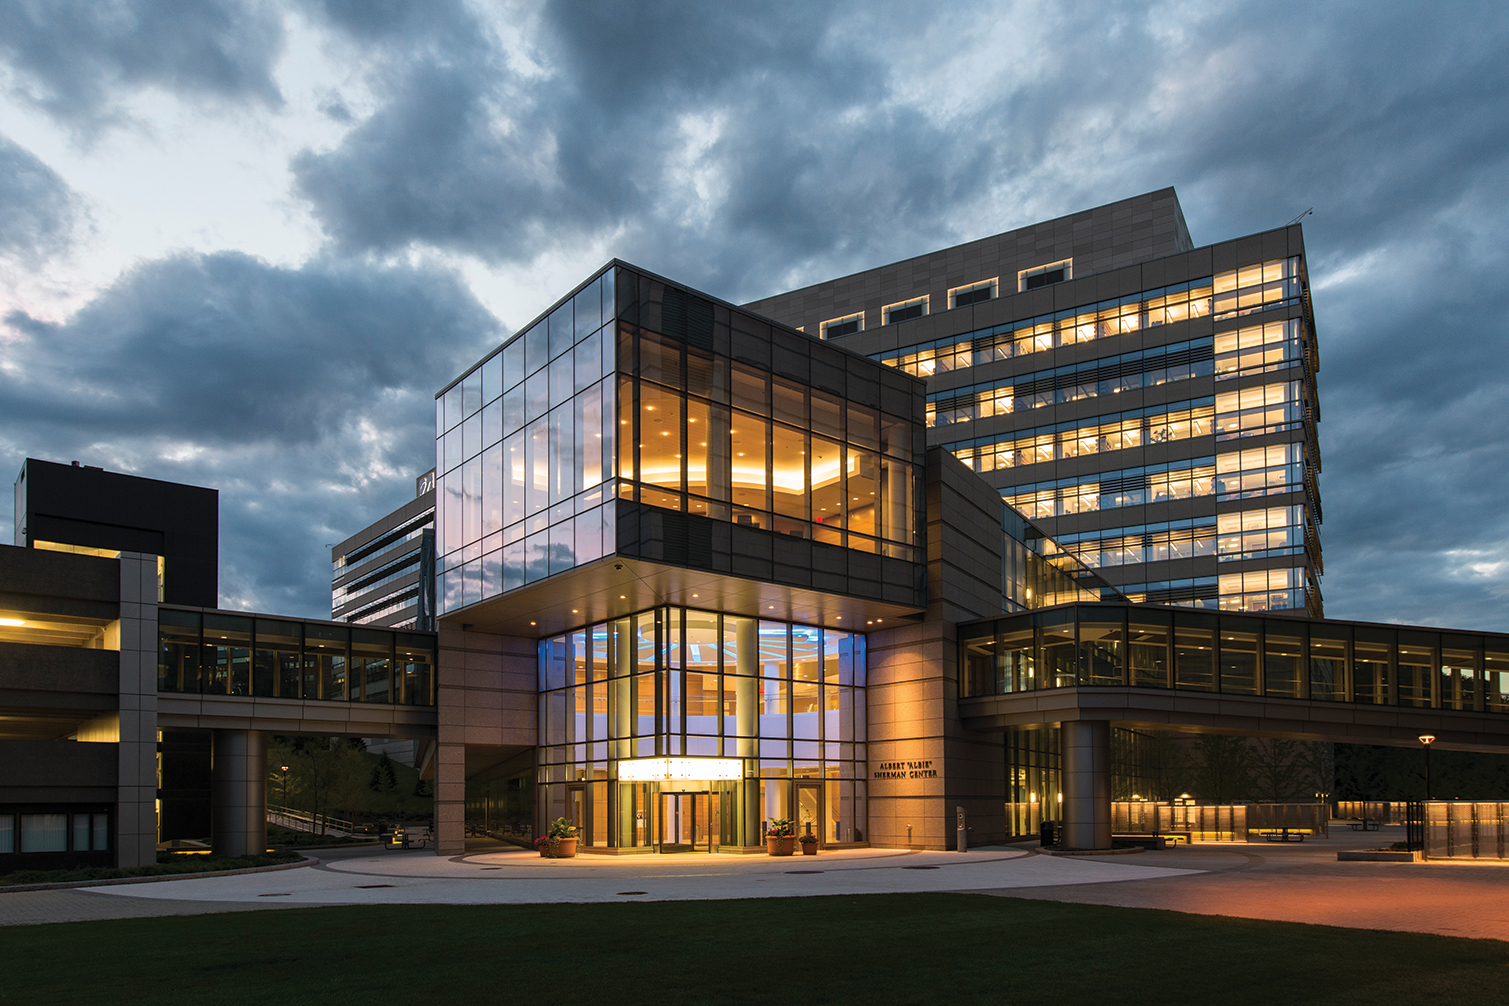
top-left (157, 608), bottom-right (435, 706)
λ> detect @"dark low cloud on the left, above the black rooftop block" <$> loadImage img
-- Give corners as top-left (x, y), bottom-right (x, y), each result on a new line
top-left (0, 253), bottom-right (498, 617)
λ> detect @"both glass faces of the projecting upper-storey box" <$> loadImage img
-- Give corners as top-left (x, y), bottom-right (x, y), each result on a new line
top-left (436, 265), bottom-right (922, 614)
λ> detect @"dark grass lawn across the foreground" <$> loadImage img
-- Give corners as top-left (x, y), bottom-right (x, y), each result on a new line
top-left (0, 894), bottom-right (1509, 1006)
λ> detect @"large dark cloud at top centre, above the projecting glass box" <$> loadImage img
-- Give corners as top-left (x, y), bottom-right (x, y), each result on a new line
top-left (294, 3), bottom-right (959, 282)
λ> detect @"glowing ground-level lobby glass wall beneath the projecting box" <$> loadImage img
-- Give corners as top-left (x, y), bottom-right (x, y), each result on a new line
top-left (537, 608), bottom-right (868, 851)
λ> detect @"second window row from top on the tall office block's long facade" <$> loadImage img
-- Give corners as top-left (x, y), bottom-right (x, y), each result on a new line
top-left (927, 339), bottom-right (1215, 427)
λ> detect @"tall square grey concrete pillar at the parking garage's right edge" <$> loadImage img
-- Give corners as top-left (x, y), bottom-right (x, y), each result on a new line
top-left (107, 552), bottom-right (157, 866)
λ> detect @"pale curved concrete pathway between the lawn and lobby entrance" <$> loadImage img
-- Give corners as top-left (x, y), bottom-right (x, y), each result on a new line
top-left (86, 849), bottom-right (1200, 906)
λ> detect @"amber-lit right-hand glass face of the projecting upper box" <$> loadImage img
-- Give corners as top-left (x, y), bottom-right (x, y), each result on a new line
top-left (617, 295), bottom-right (922, 561)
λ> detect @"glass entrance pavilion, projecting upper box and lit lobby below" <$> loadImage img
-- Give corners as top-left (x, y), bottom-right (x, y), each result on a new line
top-left (436, 262), bottom-right (923, 852)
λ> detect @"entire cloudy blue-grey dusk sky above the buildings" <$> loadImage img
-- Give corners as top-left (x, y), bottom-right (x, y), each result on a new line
top-left (0, 0), bottom-right (1509, 630)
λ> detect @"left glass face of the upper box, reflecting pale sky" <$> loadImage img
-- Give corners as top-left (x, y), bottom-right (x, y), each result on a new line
top-left (435, 268), bottom-right (617, 612)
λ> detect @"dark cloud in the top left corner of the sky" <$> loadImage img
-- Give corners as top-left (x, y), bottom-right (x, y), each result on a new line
top-left (0, 0), bottom-right (282, 130)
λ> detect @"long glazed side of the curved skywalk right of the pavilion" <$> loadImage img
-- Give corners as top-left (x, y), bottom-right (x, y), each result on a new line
top-left (960, 605), bottom-right (1509, 713)
